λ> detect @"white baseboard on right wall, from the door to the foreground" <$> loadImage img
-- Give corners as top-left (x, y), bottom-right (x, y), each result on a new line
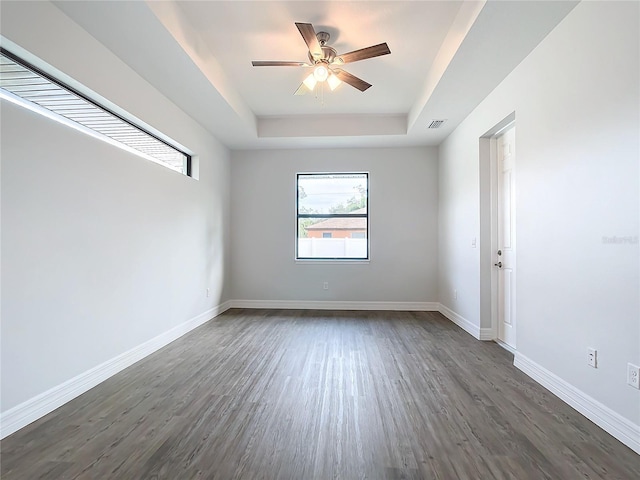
top-left (513, 352), bottom-right (640, 454)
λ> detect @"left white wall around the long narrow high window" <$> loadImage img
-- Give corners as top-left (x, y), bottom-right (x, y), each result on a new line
top-left (0, 2), bottom-right (230, 416)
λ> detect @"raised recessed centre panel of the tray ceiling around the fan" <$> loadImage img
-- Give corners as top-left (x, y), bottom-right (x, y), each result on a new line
top-left (180, 1), bottom-right (462, 115)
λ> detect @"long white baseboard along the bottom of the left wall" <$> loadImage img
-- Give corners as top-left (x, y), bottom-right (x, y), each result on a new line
top-left (0, 301), bottom-right (231, 438)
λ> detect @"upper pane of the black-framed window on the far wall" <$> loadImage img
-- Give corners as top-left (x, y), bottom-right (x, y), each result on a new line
top-left (298, 173), bottom-right (367, 214)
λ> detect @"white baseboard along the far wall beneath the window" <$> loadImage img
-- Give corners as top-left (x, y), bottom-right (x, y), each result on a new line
top-left (231, 300), bottom-right (439, 312)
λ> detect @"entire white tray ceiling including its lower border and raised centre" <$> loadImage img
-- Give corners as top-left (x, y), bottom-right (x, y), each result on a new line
top-left (55, 0), bottom-right (577, 149)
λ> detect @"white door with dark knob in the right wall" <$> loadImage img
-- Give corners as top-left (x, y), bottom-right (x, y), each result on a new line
top-left (494, 127), bottom-right (516, 349)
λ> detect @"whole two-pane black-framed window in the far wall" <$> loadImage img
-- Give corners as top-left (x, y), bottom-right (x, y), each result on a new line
top-left (296, 173), bottom-right (369, 260)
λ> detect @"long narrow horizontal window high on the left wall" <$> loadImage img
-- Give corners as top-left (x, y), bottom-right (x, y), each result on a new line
top-left (0, 48), bottom-right (191, 176)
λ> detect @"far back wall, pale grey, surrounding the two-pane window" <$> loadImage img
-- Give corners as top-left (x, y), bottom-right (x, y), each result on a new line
top-left (231, 148), bottom-right (438, 302)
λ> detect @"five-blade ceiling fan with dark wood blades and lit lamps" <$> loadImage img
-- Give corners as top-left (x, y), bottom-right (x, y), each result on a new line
top-left (251, 22), bottom-right (391, 95)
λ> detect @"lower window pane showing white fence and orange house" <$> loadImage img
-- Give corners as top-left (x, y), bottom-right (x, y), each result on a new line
top-left (298, 217), bottom-right (368, 259)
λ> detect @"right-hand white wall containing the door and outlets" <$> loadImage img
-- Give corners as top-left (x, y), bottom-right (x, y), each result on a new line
top-left (438, 2), bottom-right (640, 430)
